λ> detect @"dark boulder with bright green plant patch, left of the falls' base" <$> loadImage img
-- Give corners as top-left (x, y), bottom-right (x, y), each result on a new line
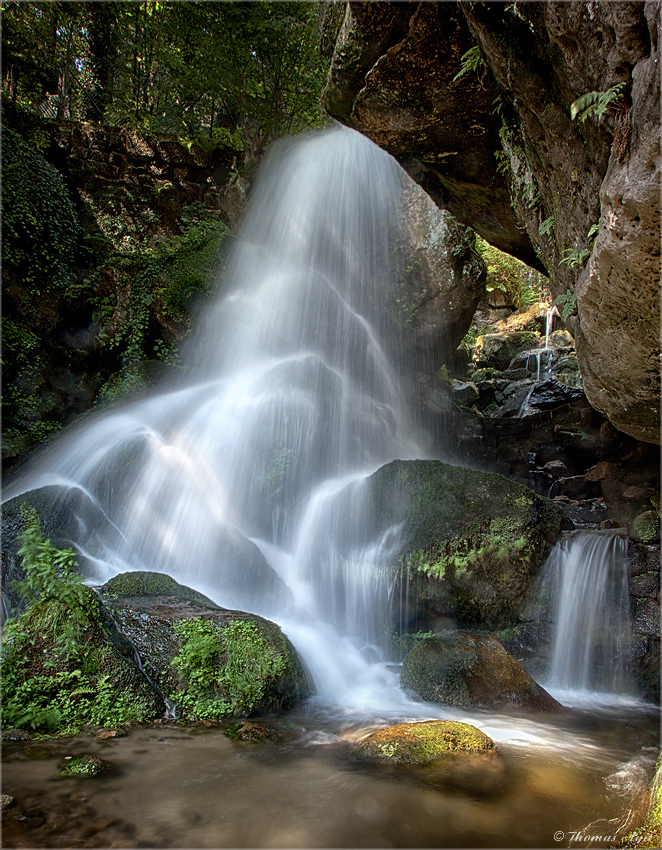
top-left (99, 572), bottom-right (312, 720)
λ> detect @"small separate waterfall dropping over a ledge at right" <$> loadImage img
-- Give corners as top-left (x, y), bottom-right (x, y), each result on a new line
top-left (540, 531), bottom-right (632, 702)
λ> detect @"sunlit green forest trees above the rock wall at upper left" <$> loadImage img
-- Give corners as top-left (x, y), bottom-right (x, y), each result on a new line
top-left (3, 0), bottom-right (328, 155)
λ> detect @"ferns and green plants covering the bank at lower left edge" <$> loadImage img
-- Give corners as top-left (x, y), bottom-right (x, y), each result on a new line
top-left (2, 506), bottom-right (149, 734)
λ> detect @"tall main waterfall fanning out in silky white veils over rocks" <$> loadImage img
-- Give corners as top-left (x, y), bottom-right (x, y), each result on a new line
top-left (4, 128), bottom-right (424, 708)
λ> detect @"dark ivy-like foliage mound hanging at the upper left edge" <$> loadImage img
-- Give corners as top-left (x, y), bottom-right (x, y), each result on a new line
top-left (2, 128), bottom-right (79, 294)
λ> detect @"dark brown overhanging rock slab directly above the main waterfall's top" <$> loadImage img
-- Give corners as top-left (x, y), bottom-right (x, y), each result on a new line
top-left (325, 3), bottom-right (538, 265)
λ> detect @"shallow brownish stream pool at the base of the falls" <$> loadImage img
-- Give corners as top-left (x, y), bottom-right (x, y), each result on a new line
top-left (3, 700), bottom-right (658, 848)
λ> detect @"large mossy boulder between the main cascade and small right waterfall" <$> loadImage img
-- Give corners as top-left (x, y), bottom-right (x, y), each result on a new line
top-left (367, 460), bottom-right (563, 630)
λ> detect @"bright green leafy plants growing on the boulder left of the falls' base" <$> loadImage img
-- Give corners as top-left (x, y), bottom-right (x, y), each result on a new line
top-left (172, 617), bottom-right (286, 720)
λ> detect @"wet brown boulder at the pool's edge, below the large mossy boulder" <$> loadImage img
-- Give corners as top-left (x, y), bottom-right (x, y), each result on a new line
top-left (400, 633), bottom-right (561, 711)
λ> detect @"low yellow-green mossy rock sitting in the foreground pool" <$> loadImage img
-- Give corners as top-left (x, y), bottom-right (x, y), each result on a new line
top-left (354, 720), bottom-right (494, 765)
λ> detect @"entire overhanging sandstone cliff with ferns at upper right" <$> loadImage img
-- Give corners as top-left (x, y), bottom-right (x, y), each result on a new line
top-left (326, 2), bottom-right (660, 442)
